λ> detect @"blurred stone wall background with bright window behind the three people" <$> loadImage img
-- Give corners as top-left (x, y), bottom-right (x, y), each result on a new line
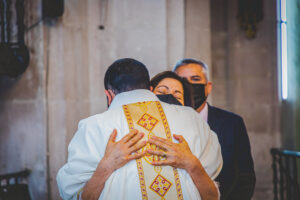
top-left (0, 0), bottom-right (300, 200)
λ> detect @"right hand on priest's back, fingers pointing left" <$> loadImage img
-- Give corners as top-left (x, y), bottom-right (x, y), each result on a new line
top-left (147, 134), bottom-right (199, 171)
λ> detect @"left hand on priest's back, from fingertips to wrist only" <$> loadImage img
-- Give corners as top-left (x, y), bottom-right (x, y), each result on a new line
top-left (101, 130), bottom-right (147, 170)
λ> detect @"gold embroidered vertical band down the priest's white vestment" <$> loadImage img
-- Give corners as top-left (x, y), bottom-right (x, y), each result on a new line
top-left (123, 101), bottom-right (183, 200)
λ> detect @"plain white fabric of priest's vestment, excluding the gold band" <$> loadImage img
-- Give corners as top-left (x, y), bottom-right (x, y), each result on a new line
top-left (57, 90), bottom-right (223, 200)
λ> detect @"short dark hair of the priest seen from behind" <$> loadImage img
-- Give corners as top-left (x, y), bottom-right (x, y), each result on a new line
top-left (104, 58), bottom-right (150, 94)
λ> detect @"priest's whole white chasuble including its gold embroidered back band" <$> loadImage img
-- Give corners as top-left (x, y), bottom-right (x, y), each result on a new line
top-left (56, 90), bottom-right (223, 200)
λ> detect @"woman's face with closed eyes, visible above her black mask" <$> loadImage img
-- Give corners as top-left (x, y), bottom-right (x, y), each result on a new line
top-left (153, 78), bottom-right (184, 105)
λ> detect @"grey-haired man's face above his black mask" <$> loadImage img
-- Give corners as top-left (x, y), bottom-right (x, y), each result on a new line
top-left (176, 63), bottom-right (206, 84)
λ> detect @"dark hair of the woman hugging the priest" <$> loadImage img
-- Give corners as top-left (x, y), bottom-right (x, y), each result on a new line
top-left (150, 71), bottom-right (194, 107)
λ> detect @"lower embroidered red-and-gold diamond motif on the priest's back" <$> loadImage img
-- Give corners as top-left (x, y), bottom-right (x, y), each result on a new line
top-left (150, 175), bottom-right (172, 197)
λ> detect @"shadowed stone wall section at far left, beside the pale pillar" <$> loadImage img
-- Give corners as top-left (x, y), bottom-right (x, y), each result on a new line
top-left (0, 1), bottom-right (47, 199)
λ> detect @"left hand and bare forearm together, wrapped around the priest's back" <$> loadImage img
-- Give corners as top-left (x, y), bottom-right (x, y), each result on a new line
top-left (82, 130), bottom-right (146, 200)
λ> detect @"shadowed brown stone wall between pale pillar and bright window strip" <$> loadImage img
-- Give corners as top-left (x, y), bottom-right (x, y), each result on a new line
top-left (211, 0), bottom-right (280, 200)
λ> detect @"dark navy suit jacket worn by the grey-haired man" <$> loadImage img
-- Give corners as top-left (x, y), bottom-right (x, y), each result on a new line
top-left (207, 105), bottom-right (256, 200)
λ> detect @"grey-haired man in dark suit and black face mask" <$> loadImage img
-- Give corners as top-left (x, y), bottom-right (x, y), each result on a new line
top-left (174, 59), bottom-right (256, 200)
